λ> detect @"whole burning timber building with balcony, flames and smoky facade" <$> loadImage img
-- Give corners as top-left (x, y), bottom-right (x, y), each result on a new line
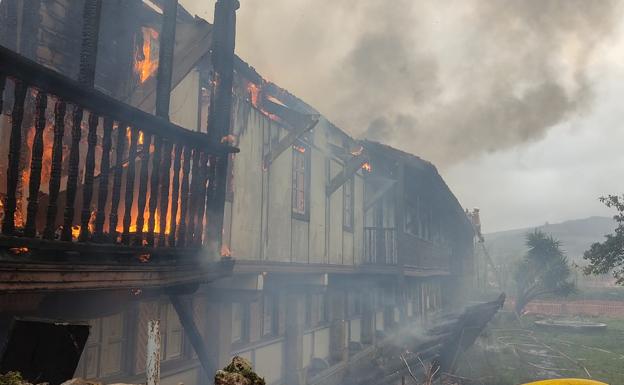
top-left (0, 0), bottom-right (488, 384)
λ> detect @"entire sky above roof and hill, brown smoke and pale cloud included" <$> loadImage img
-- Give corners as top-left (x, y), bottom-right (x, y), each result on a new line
top-left (180, 0), bottom-right (624, 232)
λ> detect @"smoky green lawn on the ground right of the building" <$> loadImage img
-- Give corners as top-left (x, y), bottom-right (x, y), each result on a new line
top-left (459, 314), bottom-right (624, 385)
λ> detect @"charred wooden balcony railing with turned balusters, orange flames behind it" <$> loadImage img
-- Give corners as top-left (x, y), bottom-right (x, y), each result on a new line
top-left (0, 47), bottom-right (237, 252)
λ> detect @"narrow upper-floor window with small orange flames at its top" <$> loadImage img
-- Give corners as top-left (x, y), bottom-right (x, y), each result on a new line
top-left (292, 142), bottom-right (310, 220)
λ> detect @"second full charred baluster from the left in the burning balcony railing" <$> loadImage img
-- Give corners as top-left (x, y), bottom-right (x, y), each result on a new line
top-left (24, 91), bottom-right (48, 237)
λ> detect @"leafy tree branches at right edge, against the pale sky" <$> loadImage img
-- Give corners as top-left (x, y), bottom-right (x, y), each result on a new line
top-left (583, 195), bottom-right (624, 285)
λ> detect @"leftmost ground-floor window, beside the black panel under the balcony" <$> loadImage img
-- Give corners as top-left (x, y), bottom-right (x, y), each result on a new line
top-left (76, 313), bottom-right (125, 379)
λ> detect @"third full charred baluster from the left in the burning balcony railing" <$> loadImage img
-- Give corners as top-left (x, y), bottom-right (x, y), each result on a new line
top-left (43, 99), bottom-right (67, 239)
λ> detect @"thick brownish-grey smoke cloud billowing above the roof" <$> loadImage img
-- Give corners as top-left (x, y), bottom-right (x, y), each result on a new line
top-left (183, 0), bottom-right (620, 165)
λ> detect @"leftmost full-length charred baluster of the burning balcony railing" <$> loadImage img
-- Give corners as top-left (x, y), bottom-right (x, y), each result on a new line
top-left (2, 80), bottom-right (27, 235)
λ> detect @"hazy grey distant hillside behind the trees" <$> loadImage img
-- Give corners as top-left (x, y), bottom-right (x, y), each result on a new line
top-left (484, 217), bottom-right (615, 261)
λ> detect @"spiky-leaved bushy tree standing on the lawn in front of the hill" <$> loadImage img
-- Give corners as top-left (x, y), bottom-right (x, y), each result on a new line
top-left (514, 230), bottom-right (575, 315)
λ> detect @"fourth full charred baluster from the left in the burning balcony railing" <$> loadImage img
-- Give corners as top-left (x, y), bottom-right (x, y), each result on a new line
top-left (61, 105), bottom-right (83, 242)
